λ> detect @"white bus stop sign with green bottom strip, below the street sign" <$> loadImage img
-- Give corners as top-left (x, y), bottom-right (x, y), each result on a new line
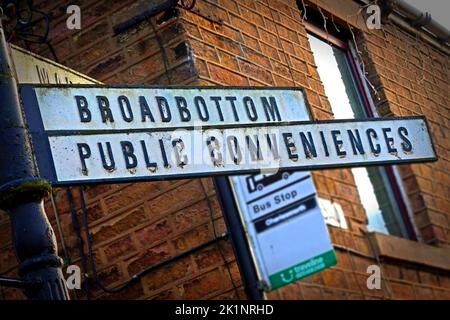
top-left (231, 172), bottom-right (336, 291)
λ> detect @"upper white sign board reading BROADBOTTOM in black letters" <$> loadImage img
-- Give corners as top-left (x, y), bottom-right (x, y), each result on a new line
top-left (24, 86), bottom-right (307, 132)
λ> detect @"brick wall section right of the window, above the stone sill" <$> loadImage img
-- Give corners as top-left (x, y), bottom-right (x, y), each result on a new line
top-left (358, 23), bottom-right (450, 247)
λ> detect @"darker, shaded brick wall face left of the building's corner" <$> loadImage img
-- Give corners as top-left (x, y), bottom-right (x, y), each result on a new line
top-left (0, 1), bottom-right (245, 299)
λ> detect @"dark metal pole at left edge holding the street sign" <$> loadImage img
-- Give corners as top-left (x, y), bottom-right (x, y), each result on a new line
top-left (0, 21), bottom-right (69, 300)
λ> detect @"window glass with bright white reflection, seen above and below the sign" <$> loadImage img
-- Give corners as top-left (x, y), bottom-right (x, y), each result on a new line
top-left (308, 34), bottom-right (414, 238)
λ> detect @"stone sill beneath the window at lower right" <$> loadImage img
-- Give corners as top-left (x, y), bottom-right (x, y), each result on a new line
top-left (369, 232), bottom-right (450, 270)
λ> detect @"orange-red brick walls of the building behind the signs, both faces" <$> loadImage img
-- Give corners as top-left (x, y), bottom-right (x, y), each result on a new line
top-left (0, 0), bottom-right (450, 299)
